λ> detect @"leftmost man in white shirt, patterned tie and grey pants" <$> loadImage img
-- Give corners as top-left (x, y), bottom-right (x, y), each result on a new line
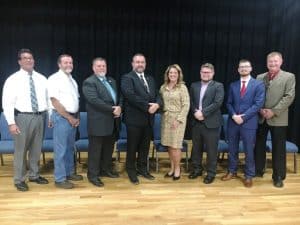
top-left (2, 49), bottom-right (48, 191)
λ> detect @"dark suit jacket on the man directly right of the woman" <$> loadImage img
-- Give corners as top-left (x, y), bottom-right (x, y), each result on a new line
top-left (190, 80), bottom-right (224, 128)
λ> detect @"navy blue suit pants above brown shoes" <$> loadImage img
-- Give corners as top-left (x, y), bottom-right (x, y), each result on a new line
top-left (228, 122), bottom-right (256, 179)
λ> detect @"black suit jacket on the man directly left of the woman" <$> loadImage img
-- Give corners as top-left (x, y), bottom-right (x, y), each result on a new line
top-left (121, 71), bottom-right (158, 126)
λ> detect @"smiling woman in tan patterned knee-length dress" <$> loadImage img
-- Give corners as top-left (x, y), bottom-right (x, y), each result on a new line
top-left (159, 64), bottom-right (190, 180)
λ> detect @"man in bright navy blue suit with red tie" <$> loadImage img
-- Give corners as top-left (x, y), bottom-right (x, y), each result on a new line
top-left (221, 59), bottom-right (265, 187)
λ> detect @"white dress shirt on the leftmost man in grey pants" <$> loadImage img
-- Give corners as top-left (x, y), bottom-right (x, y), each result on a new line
top-left (2, 69), bottom-right (48, 125)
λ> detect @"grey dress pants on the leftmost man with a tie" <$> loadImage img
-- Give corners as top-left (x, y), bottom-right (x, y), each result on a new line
top-left (14, 113), bottom-right (46, 184)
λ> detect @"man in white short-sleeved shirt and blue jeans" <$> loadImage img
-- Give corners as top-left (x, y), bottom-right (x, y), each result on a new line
top-left (48, 54), bottom-right (83, 189)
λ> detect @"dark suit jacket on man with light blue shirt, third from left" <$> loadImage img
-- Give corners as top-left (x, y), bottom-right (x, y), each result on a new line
top-left (82, 74), bottom-right (122, 136)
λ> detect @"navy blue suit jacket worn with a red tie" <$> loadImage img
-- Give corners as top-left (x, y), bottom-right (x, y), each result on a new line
top-left (227, 77), bottom-right (265, 129)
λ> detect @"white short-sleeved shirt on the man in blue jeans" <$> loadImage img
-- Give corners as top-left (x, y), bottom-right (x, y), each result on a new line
top-left (48, 70), bottom-right (79, 113)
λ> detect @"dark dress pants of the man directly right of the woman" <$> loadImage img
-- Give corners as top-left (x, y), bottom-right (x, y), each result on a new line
top-left (191, 122), bottom-right (220, 177)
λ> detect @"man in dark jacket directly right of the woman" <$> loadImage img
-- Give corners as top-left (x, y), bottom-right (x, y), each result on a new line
top-left (189, 63), bottom-right (224, 184)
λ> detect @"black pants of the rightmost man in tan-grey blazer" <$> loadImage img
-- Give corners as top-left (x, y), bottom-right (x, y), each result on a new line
top-left (255, 122), bottom-right (287, 179)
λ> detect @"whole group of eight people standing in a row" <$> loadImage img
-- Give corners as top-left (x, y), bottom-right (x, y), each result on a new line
top-left (2, 49), bottom-right (295, 191)
